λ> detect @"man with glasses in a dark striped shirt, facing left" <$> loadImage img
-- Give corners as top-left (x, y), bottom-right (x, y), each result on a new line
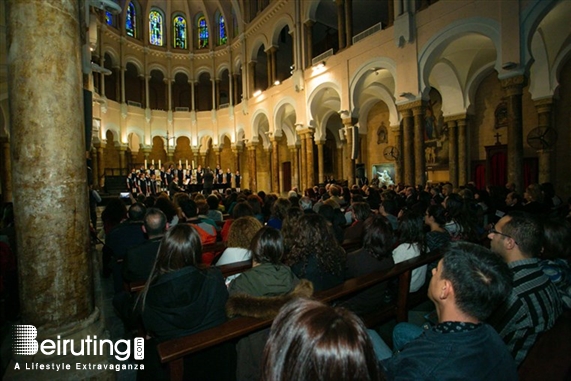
top-left (488, 212), bottom-right (562, 366)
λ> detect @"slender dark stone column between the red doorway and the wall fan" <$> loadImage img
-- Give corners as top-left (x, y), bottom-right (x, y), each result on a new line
top-left (501, 75), bottom-right (525, 189)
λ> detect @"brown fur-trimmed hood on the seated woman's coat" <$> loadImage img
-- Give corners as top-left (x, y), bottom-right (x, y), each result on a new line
top-left (226, 279), bottom-right (313, 319)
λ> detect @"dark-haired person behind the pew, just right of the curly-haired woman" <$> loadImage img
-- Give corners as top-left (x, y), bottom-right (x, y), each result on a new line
top-left (341, 215), bottom-right (395, 315)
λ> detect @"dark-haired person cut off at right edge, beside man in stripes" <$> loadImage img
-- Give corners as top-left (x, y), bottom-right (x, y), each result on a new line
top-left (539, 217), bottom-right (571, 310)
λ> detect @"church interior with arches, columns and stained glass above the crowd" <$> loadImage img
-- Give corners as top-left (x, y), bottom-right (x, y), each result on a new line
top-left (0, 0), bottom-right (571, 378)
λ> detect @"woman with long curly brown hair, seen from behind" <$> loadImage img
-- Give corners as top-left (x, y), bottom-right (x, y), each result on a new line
top-left (285, 214), bottom-right (346, 291)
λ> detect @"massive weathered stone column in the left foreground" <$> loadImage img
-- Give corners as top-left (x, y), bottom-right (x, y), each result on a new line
top-left (6, 0), bottom-right (106, 374)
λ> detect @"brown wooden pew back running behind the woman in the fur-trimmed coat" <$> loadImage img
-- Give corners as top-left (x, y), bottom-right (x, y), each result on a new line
top-left (157, 252), bottom-right (441, 380)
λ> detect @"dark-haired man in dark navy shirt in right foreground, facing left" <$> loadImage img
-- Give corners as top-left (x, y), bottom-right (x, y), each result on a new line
top-left (376, 242), bottom-right (518, 381)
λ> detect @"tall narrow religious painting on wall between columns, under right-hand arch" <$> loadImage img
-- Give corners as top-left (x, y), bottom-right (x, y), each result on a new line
top-left (424, 89), bottom-right (448, 169)
